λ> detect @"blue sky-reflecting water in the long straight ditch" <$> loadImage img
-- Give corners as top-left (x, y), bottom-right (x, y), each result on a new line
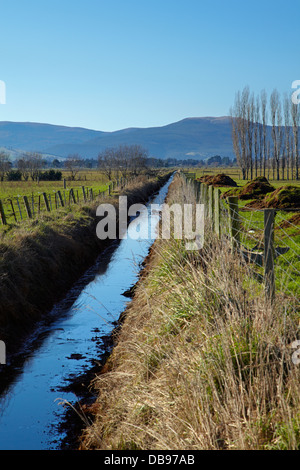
top-left (0, 174), bottom-right (172, 450)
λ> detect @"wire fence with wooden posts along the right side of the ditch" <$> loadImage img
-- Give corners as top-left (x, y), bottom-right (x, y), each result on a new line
top-left (182, 173), bottom-right (300, 310)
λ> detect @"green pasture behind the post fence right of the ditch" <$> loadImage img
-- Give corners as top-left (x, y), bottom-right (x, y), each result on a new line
top-left (188, 169), bottom-right (300, 303)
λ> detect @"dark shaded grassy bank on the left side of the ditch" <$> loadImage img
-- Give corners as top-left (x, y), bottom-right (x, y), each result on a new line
top-left (0, 175), bottom-right (171, 356)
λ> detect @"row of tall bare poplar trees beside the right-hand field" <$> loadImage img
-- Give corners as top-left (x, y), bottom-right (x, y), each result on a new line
top-left (230, 86), bottom-right (300, 180)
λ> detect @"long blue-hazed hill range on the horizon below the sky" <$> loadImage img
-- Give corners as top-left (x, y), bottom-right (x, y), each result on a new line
top-left (0, 116), bottom-right (234, 160)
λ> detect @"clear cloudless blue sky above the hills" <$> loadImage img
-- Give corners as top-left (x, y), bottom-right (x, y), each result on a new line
top-left (0, 0), bottom-right (300, 131)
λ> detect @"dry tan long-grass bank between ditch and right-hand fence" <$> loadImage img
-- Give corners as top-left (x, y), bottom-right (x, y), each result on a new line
top-left (81, 173), bottom-right (300, 450)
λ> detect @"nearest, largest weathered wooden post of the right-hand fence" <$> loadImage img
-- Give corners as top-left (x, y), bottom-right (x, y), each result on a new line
top-left (264, 209), bottom-right (275, 303)
